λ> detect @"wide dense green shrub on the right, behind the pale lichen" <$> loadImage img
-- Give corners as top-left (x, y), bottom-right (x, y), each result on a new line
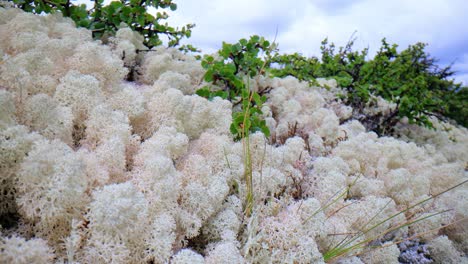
top-left (272, 39), bottom-right (467, 132)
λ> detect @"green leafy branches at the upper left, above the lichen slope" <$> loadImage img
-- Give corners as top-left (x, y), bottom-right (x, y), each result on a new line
top-left (5, 0), bottom-right (195, 48)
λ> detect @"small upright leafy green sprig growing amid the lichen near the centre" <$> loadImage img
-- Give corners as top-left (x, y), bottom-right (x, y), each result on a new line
top-left (197, 36), bottom-right (275, 140)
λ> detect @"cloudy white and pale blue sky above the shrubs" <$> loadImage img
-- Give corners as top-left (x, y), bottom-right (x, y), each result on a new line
top-left (162, 0), bottom-right (468, 85)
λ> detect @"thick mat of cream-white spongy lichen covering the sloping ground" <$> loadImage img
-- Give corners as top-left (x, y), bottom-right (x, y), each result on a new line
top-left (0, 6), bottom-right (468, 263)
